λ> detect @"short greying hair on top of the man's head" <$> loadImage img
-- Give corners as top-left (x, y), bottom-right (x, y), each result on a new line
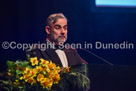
top-left (46, 13), bottom-right (67, 26)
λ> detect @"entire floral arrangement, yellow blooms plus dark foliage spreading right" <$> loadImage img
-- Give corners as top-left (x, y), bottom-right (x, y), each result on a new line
top-left (0, 57), bottom-right (89, 91)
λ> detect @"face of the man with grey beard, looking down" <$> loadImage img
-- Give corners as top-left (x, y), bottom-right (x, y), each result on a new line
top-left (50, 18), bottom-right (67, 43)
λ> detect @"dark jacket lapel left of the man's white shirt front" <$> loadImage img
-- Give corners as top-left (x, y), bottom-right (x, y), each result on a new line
top-left (45, 49), bottom-right (62, 66)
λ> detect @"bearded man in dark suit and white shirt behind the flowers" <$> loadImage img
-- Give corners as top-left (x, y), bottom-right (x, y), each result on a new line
top-left (27, 13), bottom-right (87, 91)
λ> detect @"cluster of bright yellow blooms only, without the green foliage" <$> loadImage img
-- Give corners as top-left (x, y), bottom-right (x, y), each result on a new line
top-left (16, 57), bottom-right (60, 89)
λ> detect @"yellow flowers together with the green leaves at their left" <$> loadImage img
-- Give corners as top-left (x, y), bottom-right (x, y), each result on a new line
top-left (3, 57), bottom-right (71, 90)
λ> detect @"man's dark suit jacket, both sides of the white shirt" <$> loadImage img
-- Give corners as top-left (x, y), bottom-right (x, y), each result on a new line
top-left (26, 49), bottom-right (87, 67)
